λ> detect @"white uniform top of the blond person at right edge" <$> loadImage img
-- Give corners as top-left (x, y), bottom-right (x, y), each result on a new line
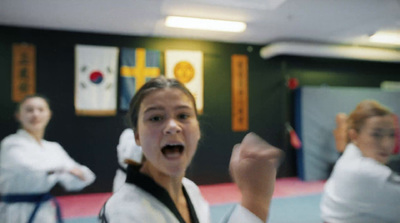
top-left (321, 143), bottom-right (400, 223)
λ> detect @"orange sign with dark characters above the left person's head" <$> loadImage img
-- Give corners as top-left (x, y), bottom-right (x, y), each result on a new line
top-left (11, 43), bottom-right (36, 102)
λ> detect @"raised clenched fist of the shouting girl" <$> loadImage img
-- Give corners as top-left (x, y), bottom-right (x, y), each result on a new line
top-left (229, 133), bottom-right (283, 222)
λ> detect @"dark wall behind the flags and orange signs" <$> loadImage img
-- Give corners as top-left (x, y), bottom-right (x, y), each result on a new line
top-left (0, 26), bottom-right (400, 193)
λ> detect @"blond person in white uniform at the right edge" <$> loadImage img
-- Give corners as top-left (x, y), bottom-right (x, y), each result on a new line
top-left (320, 100), bottom-right (400, 223)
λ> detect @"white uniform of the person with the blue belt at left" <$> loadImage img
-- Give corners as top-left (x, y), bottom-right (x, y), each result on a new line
top-left (0, 129), bottom-right (95, 223)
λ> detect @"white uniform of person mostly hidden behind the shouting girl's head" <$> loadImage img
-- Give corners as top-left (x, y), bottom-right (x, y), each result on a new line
top-left (113, 128), bottom-right (142, 192)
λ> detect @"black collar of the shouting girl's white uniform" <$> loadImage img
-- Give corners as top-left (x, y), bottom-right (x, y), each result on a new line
top-left (126, 165), bottom-right (199, 223)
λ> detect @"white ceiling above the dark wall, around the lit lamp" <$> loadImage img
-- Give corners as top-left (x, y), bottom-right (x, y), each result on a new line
top-left (0, 0), bottom-right (400, 49)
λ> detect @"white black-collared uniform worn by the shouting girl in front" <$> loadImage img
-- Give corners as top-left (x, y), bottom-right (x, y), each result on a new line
top-left (100, 166), bottom-right (262, 223)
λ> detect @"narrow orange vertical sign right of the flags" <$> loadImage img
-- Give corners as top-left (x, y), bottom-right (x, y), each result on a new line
top-left (231, 54), bottom-right (249, 132)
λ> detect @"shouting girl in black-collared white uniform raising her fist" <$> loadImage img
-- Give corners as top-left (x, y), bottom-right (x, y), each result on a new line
top-left (99, 76), bottom-right (282, 223)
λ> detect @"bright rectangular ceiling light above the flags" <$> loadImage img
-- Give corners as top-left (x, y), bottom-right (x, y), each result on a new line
top-left (165, 16), bottom-right (246, 32)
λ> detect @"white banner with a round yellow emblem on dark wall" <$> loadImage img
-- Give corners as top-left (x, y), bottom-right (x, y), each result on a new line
top-left (165, 50), bottom-right (204, 114)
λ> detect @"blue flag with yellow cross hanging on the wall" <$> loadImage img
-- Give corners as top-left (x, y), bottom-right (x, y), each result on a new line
top-left (120, 48), bottom-right (161, 110)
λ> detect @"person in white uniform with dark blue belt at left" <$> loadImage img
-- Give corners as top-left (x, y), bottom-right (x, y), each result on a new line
top-left (0, 95), bottom-right (95, 223)
